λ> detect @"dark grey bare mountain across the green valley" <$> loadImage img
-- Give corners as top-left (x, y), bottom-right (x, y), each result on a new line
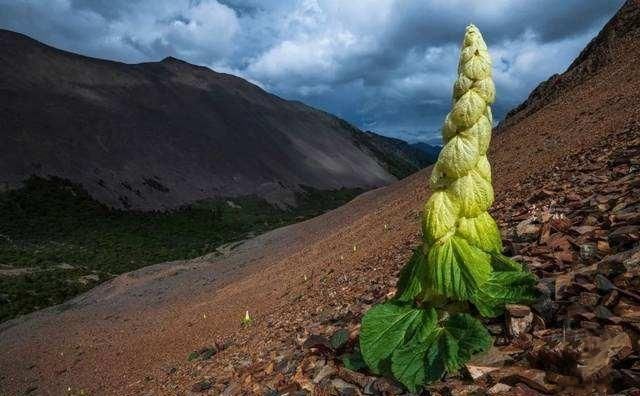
top-left (0, 30), bottom-right (430, 209)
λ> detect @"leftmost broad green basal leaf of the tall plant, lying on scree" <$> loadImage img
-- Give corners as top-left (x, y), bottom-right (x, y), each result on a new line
top-left (360, 301), bottom-right (427, 374)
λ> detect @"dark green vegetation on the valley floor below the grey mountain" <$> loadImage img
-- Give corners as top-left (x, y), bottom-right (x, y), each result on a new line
top-left (0, 177), bottom-right (362, 321)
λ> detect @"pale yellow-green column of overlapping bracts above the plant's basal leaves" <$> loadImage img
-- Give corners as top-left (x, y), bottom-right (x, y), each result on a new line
top-left (423, 25), bottom-right (502, 300)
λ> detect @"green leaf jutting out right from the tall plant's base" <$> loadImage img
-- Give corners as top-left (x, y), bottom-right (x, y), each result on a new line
top-left (471, 271), bottom-right (538, 317)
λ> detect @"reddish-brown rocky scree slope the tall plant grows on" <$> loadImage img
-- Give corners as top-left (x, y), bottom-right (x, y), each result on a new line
top-left (0, 1), bottom-right (640, 395)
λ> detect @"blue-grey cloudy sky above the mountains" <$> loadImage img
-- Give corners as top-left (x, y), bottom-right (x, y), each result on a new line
top-left (0, 0), bottom-right (622, 141)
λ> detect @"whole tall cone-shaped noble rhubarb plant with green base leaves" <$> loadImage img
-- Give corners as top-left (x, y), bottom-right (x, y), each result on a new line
top-left (360, 25), bottom-right (536, 391)
